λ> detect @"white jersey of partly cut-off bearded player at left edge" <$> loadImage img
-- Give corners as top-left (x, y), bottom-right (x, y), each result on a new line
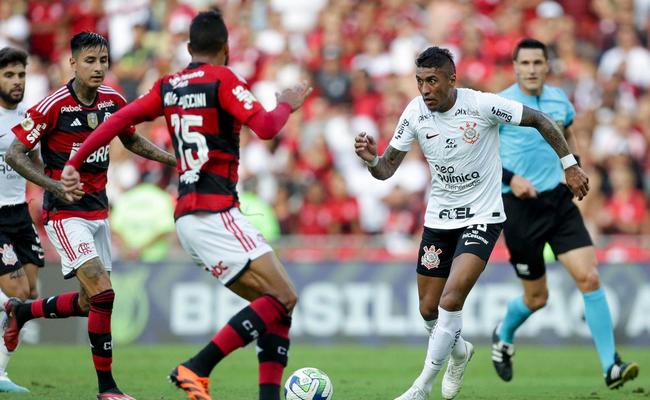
top-left (0, 105), bottom-right (26, 206)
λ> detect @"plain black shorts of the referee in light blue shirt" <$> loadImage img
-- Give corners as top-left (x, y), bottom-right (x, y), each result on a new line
top-left (503, 184), bottom-right (593, 280)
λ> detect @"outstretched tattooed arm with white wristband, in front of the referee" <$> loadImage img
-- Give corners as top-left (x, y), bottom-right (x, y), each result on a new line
top-left (519, 106), bottom-right (589, 200)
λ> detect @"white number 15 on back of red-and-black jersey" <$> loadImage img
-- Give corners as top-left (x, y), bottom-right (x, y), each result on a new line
top-left (170, 114), bottom-right (208, 171)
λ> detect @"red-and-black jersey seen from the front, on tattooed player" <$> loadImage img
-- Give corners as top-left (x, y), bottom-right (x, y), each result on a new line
top-left (12, 81), bottom-right (134, 221)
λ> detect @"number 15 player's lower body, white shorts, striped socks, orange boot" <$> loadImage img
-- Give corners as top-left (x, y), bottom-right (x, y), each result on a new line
top-left (170, 209), bottom-right (297, 400)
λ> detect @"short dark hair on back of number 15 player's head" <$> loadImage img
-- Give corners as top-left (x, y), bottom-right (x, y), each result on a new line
top-left (190, 9), bottom-right (228, 54)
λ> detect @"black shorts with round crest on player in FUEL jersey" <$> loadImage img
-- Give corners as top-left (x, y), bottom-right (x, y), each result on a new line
top-left (417, 224), bottom-right (503, 278)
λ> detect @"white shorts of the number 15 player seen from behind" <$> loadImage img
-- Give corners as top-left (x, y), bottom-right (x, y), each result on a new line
top-left (176, 208), bottom-right (273, 285)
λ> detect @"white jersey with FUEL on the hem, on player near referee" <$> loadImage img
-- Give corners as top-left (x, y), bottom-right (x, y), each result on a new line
top-left (390, 89), bottom-right (523, 229)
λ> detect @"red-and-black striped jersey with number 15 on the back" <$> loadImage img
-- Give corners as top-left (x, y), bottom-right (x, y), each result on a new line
top-left (143, 63), bottom-right (262, 218)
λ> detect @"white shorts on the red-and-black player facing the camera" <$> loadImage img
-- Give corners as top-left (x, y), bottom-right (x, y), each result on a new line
top-left (45, 217), bottom-right (111, 279)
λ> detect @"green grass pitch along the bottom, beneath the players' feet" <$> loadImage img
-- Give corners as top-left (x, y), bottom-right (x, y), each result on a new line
top-left (5, 345), bottom-right (650, 400)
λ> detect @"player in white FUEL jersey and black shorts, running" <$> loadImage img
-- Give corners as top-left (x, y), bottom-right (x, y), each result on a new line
top-left (355, 47), bottom-right (589, 400)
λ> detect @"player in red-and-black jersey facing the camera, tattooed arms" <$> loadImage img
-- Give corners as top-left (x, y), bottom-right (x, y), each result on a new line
top-left (4, 32), bottom-right (176, 399)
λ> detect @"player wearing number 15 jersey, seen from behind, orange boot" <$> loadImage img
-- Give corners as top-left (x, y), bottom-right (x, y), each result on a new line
top-left (62, 11), bottom-right (311, 400)
